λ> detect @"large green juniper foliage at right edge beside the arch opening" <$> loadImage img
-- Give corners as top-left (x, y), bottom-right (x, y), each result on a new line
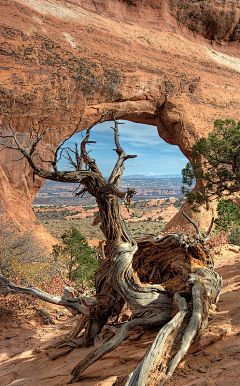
top-left (182, 119), bottom-right (240, 208)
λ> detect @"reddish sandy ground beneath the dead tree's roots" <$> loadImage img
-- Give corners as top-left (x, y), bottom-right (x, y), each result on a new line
top-left (0, 250), bottom-right (240, 386)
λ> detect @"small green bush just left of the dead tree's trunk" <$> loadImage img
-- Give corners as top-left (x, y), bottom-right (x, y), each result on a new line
top-left (53, 227), bottom-right (98, 285)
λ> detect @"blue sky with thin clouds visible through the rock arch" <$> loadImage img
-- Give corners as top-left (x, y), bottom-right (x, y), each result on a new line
top-left (59, 121), bottom-right (187, 177)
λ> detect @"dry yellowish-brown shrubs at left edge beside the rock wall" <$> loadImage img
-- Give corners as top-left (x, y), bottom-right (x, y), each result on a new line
top-left (0, 221), bottom-right (72, 318)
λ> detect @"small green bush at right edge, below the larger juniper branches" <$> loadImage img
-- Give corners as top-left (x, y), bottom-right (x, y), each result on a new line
top-left (214, 200), bottom-right (240, 232)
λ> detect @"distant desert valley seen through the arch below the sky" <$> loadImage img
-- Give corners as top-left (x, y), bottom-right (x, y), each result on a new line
top-left (33, 176), bottom-right (185, 241)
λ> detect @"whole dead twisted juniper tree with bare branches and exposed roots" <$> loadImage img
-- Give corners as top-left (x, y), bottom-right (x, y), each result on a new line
top-left (0, 115), bottom-right (222, 386)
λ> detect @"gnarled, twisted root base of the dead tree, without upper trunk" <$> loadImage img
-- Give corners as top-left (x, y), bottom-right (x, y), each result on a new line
top-left (0, 228), bottom-right (222, 386)
